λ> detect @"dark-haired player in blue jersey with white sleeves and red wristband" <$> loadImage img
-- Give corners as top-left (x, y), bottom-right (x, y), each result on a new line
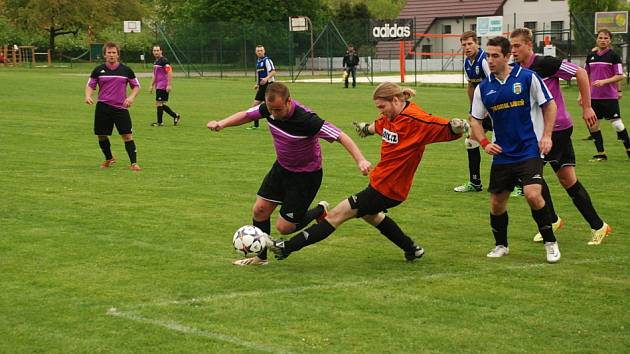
top-left (471, 37), bottom-right (560, 263)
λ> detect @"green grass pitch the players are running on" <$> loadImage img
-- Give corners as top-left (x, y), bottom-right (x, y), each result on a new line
top-left (0, 69), bottom-right (630, 353)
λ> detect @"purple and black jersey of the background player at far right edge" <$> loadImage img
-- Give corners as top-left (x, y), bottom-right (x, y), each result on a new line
top-left (584, 48), bottom-right (623, 100)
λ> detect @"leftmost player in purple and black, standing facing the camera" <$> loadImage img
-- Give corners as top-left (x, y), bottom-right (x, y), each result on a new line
top-left (85, 42), bottom-right (142, 171)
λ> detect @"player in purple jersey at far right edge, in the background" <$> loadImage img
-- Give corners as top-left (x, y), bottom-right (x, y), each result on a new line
top-left (580, 29), bottom-right (630, 161)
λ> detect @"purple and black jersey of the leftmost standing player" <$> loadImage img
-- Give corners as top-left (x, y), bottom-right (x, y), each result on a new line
top-left (87, 64), bottom-right (140, 109)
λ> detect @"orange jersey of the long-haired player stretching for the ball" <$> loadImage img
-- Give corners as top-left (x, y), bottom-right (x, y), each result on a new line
top-left (370, 103), bottom-right (460, 201)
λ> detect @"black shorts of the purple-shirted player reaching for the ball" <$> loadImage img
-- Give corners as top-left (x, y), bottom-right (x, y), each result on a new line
top-left (258, 161), bottom-right (322, 224)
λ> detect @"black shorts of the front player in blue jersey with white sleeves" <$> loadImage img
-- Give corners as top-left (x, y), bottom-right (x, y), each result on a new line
top-left (488, 157), bottom-right (543, 193)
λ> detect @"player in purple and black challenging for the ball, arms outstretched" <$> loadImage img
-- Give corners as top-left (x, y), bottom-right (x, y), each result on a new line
top-left (207, 83), bottom-right (372, 265)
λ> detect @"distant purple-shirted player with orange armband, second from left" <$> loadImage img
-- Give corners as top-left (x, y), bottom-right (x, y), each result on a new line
top-left (149, 44), bottom-right (182, 127)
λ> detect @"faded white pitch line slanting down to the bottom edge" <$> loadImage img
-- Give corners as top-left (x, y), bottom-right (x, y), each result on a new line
top-left (107, 308), bottom-right (290, 353)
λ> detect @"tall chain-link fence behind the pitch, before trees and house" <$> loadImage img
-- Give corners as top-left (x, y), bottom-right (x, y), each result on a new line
top-left (12, 13), bottom-right (630, 82)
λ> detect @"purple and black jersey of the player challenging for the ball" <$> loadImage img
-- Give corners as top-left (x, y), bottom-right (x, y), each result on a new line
top-left (247, 100), bottom-right (341, 172)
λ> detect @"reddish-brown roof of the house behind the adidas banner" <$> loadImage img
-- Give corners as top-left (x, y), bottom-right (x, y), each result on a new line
top-left (376, 0), bottom-right (507, 56)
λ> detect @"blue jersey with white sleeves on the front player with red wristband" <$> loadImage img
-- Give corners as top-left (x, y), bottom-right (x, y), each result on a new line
top-left (471, 64), bottom-right (553, 164)
